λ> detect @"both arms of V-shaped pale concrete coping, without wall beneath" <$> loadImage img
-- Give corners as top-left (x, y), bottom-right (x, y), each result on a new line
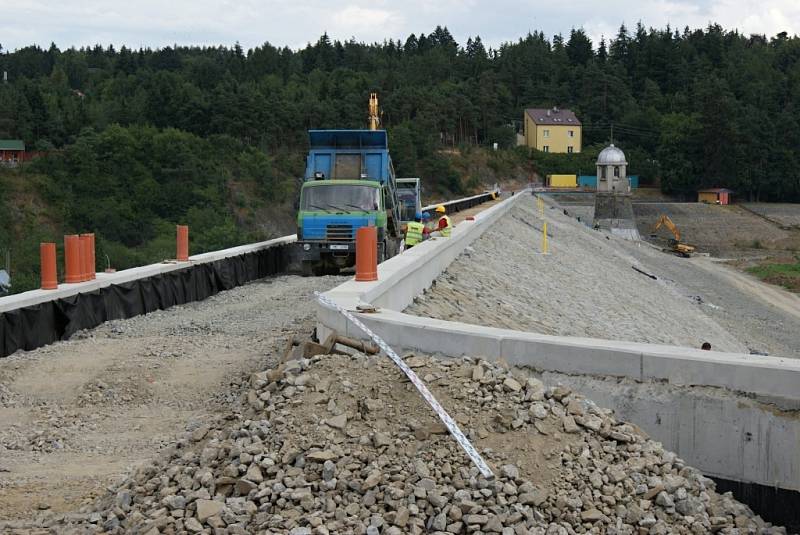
top-left (317, 193), bottom-right (800, 406)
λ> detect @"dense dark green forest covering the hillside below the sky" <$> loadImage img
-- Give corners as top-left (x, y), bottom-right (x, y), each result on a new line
top-left (0, 25), bottom-right (800, 294)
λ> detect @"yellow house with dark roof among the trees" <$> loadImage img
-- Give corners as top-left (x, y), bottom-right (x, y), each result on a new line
top-left (524, 108), bottom-right (582, 153)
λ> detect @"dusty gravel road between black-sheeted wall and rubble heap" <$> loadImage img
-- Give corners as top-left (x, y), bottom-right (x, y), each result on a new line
top-left (0, 276), bottom-right (344, 531)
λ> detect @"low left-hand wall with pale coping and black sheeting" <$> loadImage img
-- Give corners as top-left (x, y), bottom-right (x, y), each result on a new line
top-left (0, 240), bottom-right (291, 358)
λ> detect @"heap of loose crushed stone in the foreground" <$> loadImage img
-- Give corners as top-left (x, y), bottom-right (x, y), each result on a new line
top-left (36, 354), bottom-right (785, 535)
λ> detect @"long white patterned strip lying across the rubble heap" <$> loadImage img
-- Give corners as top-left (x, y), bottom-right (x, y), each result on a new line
top-left (314, 292), bottom-right (494, 479)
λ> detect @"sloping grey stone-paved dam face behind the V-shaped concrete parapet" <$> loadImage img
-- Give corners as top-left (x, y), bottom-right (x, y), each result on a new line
top-left (408, 197), bottom-right (747, 352)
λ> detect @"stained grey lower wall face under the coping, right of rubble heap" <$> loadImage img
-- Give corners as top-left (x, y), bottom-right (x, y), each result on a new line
top-left (542, 373), bottom-right (800, 490)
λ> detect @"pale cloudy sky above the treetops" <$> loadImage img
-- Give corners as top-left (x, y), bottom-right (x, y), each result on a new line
top-left (0, 0), bottom-right (800, 50)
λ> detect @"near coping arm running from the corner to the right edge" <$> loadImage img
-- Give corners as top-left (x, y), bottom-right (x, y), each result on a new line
top-left (318, 308), bottom-right (800, 404)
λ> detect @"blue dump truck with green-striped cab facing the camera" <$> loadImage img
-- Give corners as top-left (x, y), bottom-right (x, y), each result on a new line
top-left (297, 130), bottom-right (404, 275)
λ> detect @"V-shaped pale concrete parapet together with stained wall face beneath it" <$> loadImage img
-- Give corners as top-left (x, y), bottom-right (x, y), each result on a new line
top-left (317, 188), bottom-right (800, 491)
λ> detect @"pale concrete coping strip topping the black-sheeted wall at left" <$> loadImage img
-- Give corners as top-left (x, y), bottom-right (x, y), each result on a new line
top-left (0, 234), bottom-right (297, 312)
